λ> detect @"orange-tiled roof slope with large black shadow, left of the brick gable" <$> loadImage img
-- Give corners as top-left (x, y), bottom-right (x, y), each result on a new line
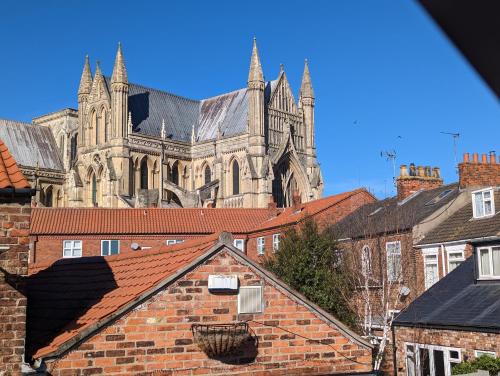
top-left (27, 235), bottom-right (218, 358)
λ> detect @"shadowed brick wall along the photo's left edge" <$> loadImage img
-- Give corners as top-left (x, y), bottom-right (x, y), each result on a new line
top-left (0, 201), bottom-right (31, 375)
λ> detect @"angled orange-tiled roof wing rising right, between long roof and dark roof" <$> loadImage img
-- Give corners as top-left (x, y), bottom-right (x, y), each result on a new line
top-left (252, 188), bottom-right (375, 232)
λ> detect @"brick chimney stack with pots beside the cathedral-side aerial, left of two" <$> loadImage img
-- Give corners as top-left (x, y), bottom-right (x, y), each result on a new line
top-left (396, 163), bottom-right (443, 201)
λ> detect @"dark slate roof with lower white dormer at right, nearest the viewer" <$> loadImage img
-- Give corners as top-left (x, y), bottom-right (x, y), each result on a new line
top-left (393, 256), bottom-right (500, 332)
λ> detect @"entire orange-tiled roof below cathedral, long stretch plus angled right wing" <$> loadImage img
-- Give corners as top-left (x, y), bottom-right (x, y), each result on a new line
top-left (30, 189), bottom-right (374, 235)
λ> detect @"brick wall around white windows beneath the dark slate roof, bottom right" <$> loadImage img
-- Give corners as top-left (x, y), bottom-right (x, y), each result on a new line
top-left (396, 327), bottom-right (500, 376)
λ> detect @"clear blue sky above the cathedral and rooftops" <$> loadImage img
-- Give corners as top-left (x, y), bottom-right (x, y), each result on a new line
top-left (0, 0), bottom-right (500, 197)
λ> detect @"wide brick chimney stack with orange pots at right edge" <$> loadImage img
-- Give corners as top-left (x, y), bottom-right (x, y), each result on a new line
top-left (458, 151), bottom-right (500, 188)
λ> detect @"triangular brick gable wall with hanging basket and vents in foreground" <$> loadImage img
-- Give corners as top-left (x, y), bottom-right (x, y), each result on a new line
top-left (43, 251), bottom-right (371, 376)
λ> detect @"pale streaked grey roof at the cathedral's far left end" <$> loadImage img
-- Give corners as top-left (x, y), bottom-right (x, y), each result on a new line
top-left (0, 119), bottom-right (64, 171)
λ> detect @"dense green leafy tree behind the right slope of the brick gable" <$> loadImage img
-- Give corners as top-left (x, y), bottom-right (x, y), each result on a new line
top-left (264, 218), bottom-right (355, 327)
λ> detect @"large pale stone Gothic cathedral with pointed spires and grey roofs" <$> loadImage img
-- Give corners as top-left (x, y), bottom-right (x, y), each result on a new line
top-left (0, 40), bottom-right (323, 208)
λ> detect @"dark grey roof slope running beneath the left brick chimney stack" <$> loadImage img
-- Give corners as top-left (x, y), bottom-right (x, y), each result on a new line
top-left (332, 183), bottom-right (459, 239)
